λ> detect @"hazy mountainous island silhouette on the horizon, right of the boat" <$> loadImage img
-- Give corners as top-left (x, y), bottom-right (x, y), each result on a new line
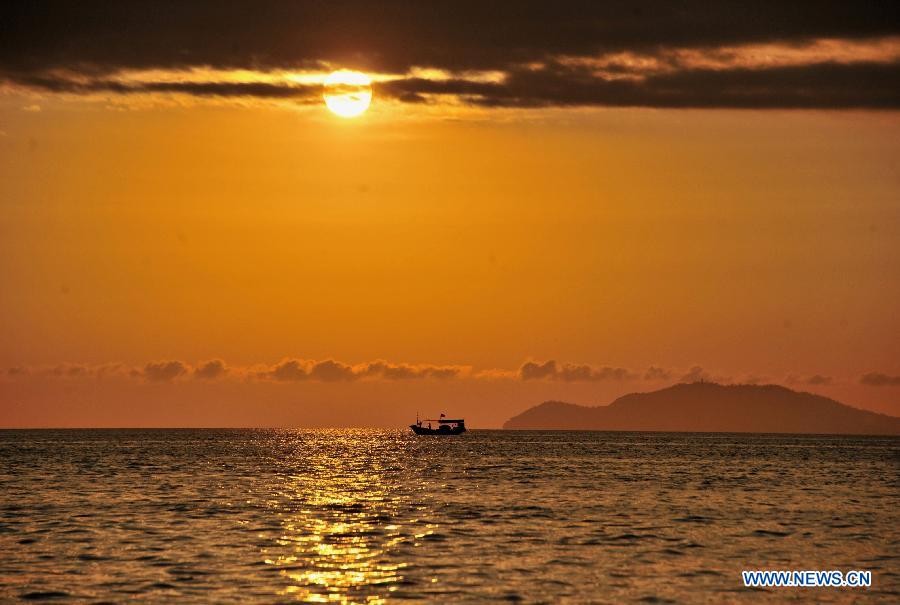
top-left (503, 382), bottom-right (900, 435)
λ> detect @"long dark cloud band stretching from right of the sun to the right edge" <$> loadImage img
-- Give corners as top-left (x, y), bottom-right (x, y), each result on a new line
top-left (382, 63), bottom-right (900, 109)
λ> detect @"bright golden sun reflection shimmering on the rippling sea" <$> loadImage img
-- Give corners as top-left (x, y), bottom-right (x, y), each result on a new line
top-left (263, 432), bottom-right (417, 604)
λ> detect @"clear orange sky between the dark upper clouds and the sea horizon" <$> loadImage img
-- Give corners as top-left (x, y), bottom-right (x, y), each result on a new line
top-left (0, 94), bottom-right (900, 426)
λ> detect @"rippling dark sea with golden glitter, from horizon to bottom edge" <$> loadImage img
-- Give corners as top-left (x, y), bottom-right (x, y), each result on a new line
top-left (0, 430), bottom-right (900, 603)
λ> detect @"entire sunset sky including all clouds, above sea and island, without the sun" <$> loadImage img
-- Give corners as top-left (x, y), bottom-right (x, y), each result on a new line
top-left (0, 1), bottom-right (900, 428)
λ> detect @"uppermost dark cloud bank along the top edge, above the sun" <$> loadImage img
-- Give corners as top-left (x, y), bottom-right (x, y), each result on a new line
top-left (0, 0), bottom-right (898, 73)
